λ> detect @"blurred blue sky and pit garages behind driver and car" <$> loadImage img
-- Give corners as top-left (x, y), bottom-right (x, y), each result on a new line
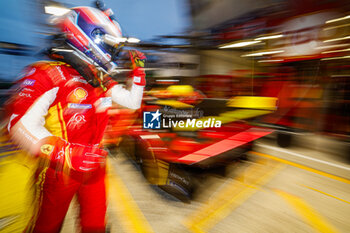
top-left (0, 0), bottom-right (350, 146)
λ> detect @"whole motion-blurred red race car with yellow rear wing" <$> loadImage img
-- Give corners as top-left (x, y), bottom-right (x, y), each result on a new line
top-left (102, 87), bottom-right (277, 202)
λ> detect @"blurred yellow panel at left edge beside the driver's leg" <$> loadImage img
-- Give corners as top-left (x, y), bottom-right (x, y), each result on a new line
top-left (0, 152), bottom-right (35, 233)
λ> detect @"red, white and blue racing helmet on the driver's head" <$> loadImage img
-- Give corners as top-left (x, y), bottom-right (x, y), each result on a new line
top-left (58, 7), bottom-right (123, 74)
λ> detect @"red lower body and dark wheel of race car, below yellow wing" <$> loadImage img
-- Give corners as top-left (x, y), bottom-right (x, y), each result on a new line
top-left (122, 123), bottom-right (271, 202)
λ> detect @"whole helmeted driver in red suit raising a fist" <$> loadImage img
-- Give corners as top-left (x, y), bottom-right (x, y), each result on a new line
top-left (8, 7), bottom-right (146, 233)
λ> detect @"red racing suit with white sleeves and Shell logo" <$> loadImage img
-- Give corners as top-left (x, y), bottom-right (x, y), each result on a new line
top-left (8, 61), bottom-right (143, 232)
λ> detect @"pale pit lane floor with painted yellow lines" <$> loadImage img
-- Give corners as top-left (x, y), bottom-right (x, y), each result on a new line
top-left (62, 141), bottom-right (350, 233)
